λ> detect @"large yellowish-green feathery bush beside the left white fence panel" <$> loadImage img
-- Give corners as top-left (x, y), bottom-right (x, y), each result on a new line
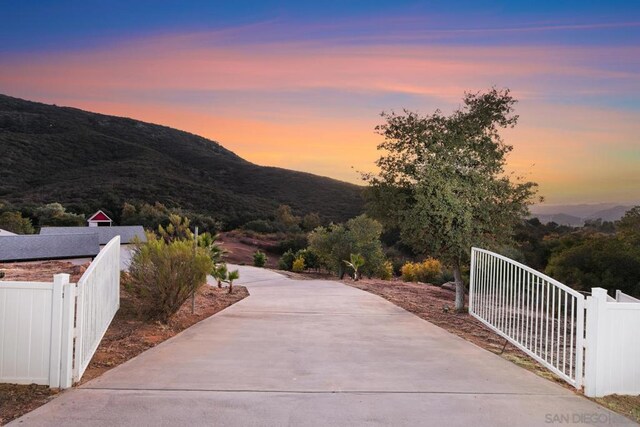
top-left (129, 238), bottom-right (213, 323)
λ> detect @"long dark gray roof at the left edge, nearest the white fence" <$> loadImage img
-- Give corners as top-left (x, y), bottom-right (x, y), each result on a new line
top-left (0, 234), bottom-right (100, 262)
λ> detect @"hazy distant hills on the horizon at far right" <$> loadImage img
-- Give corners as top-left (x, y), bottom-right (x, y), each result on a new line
top-left (531, 203), bottom-right (633, 227)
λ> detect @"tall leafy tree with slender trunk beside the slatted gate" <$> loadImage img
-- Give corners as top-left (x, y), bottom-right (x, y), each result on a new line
top-left (364, 88), bottom-right (536, 311)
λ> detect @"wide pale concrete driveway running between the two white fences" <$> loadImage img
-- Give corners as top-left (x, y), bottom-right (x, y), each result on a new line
top-left (10, 267), bottom-right (636, 427)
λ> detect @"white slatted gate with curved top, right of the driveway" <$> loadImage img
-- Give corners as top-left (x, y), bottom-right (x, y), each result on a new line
top-left (469, 248), bottom-right (585, 388)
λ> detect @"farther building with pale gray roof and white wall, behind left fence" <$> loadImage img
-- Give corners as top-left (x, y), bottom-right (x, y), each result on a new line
top-left (40, 226), bottom-right (147, 270)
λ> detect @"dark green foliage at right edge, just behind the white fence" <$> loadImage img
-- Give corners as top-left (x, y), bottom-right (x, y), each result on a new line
top-left (545, 236), bottom-right (640, 297)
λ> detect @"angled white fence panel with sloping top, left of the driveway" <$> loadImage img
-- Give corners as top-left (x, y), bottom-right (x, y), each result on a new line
top-left (73, 236), bottom-right (120, 381)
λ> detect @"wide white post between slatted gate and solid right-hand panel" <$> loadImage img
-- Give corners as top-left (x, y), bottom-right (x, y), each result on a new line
top-left (584, 288), bottom-right (607, 397)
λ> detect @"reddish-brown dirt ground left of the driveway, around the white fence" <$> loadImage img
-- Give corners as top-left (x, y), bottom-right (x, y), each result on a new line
top-left (0, 261), bottom-right (249, 425)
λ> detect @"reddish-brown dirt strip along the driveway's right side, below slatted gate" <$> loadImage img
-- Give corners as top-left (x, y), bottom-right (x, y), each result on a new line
top-left (342, 275), bottom-right (640, 422)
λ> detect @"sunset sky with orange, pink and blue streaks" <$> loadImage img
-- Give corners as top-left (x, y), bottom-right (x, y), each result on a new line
top-left (0, 0), bottom-right (640, 204)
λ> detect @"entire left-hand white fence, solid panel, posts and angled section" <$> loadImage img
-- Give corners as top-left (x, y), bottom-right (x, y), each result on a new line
top-left (0, 237), bottom-right (120, 388)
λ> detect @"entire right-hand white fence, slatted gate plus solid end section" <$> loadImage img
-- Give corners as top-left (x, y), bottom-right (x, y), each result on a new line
top-left (469, 248), bottom-right (640, 397)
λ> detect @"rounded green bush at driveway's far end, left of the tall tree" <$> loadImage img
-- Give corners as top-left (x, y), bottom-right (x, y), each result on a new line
top-left (309, 215), bottom-right (385, 278)
